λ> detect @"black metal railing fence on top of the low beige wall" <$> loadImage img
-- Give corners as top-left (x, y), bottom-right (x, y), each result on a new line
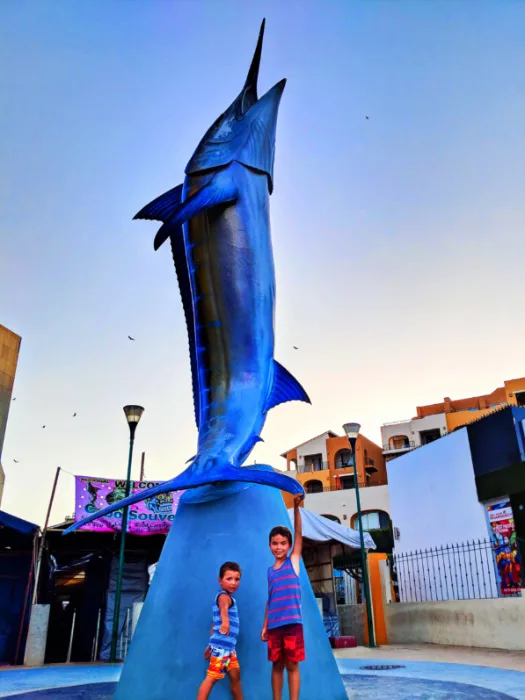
top-left (392, 539), bottom-right (521, 603)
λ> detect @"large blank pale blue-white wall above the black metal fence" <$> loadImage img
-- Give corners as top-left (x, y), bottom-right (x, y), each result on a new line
top-left (384, 428), bottom-right (488, 553)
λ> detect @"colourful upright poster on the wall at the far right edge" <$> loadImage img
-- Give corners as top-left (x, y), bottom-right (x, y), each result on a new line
top-left (487, 498), bottom-right (521, 595)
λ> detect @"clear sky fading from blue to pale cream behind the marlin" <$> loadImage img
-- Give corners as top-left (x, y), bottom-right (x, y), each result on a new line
top-left (0, 0), bottom-right (525, 523)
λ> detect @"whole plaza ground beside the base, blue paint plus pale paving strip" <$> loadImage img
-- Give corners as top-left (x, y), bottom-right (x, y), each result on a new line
top-left (0, 644), bottom-right (525, 700)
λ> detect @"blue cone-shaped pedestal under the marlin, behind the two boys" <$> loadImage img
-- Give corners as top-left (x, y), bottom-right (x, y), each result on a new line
top-left (115, 486), bottom-right (347, 700)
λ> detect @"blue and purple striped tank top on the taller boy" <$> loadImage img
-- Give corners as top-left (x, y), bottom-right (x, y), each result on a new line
top-left (268, 557), bottom-right (303, 630)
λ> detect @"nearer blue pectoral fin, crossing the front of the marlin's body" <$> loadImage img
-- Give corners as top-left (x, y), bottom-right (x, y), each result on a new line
top-left (154, 168), bottom-right (238, 250)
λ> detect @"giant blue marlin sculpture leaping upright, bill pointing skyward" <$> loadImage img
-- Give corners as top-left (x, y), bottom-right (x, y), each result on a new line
top-left (64, 20), bottom-right (310, 534)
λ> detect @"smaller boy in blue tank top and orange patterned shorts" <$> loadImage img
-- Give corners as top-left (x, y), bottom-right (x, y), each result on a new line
top-left (197, 561), bottom-right (242, 700)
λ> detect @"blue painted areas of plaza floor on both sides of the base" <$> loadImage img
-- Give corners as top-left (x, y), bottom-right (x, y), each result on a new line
top-left (0, 659), bottom-right (525, 700)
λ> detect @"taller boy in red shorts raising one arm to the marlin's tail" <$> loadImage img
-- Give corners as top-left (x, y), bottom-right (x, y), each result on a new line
top-left (261, 494), bottom-right (305, 700)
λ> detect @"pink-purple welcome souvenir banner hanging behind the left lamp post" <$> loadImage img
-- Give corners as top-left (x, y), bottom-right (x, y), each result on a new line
top-left (75, 476), bottom-right (184, 535)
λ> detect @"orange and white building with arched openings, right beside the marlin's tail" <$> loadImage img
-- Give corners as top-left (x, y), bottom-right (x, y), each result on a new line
top-left (281, 430), bottom-right (387, 493)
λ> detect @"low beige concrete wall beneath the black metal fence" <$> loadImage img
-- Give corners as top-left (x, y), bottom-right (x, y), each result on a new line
top-left (384, 597), bottom-right (525, 651)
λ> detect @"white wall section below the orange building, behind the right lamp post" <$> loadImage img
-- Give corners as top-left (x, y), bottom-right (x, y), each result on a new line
top-left (304, 486), bottom-right (390, 527)
